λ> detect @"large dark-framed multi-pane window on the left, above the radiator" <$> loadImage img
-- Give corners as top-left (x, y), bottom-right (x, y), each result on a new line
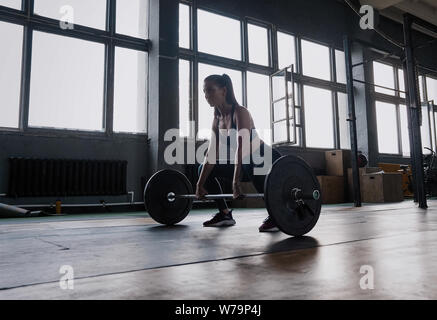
top-left (0, 0), bottom-right (149, 136)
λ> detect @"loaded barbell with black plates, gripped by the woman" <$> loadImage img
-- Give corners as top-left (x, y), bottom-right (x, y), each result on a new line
top-left (144, 155), bottom-right (322, 236)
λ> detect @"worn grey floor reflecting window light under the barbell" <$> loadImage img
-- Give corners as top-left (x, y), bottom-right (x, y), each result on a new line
top-left (0, 200), bottom-right (437, 299)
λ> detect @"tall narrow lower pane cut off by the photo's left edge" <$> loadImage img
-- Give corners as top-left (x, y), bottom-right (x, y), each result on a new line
top-left (0, 22), bottom-right (23, 128)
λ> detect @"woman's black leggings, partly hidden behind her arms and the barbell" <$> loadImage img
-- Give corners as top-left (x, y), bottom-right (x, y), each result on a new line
top-left (198, 146), bottom-right (281, 211)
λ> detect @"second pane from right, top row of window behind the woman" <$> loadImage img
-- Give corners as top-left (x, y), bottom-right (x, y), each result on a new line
top-left (302, 40), bottom-right (331, 81)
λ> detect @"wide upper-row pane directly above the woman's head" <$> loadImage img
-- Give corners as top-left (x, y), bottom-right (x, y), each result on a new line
top-left (197, 10), bottom-right (241, 60)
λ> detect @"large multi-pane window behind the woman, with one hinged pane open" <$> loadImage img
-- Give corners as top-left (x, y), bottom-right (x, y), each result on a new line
top-left (179, 1), bottom-right (344, 149)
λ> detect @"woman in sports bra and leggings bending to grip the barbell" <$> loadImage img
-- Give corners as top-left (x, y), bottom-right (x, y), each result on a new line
top-left (196, 74), bottom-right (281, 232)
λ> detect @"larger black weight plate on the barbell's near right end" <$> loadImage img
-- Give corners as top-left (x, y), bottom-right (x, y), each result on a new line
top-left (264, 155), bottom-right (322, 236)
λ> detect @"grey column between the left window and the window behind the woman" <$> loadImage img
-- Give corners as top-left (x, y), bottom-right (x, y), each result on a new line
top-left (147, 0), bottom-right (179, 175)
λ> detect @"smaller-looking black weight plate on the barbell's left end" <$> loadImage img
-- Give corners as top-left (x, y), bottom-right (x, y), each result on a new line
top-left (144, 169), bottom-right (193, 225)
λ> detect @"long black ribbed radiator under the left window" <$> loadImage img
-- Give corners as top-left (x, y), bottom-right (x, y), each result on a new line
top-left (8, 158), bottom-right (127, 197)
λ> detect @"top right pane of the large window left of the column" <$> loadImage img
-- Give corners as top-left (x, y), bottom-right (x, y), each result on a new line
top-left (116, 0), bottom-right (149, 39)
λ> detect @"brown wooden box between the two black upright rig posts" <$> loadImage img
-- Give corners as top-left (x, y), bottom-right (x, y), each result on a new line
top-left (361, 172), bottom-right (404, 203)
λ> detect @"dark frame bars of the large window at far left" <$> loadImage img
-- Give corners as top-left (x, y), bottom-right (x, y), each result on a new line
top-left (0, 0), bottom-right (151, 139)
